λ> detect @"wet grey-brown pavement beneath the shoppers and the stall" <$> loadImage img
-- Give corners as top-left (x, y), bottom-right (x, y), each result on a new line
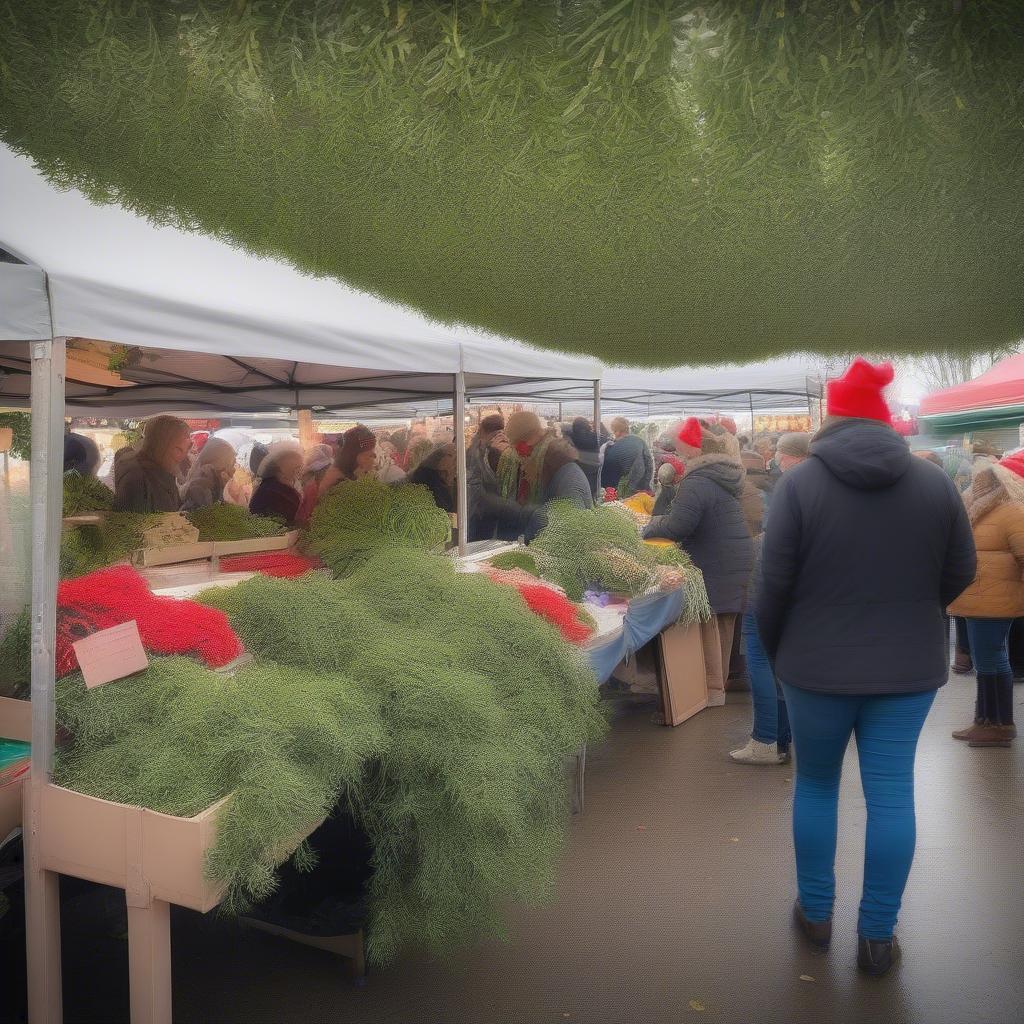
top-left (0, 677), bottom-right (1024, 1024)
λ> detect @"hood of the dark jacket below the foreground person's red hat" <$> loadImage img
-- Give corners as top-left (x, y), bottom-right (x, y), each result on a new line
top-left (811, 419), bottom-right (913, 490)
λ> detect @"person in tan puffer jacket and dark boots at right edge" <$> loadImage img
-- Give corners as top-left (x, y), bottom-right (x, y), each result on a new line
top-left (949, 456), bottom-right (1024, 746)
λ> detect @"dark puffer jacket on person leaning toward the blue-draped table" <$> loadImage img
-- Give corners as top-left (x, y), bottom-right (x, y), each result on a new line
top-left (644, 456), bottom-right (754, 614)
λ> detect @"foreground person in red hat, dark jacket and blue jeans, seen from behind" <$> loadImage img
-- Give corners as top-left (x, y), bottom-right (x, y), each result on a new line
top-left (755, 358), bottom-right (977, 976)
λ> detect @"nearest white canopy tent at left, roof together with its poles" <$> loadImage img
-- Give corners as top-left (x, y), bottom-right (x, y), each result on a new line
top-left (0, 145), bottom-right (601, 1020)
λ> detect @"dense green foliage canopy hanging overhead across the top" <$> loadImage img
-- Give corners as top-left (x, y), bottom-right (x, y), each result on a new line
top-left (0, 0), bottom-right (1024, 366)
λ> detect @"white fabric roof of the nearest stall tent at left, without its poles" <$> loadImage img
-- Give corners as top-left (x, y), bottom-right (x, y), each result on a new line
top-left (0, 145), bottom-right (601, 411)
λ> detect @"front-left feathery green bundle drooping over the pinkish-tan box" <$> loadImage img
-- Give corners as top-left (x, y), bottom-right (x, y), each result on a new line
top-left (53, 657), bottom-right (385, 911)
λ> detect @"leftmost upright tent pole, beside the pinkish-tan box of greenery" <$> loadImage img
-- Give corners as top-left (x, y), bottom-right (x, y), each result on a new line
top-left (24, 338), bottom-right (67, 1024)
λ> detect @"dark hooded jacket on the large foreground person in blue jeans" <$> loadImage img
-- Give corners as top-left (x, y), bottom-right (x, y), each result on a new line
top-left (757, 419), bottom-right (975, 694)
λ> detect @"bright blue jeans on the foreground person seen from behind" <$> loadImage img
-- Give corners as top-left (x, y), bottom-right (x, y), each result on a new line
top-left (782, 683), bottom-right (936, 939)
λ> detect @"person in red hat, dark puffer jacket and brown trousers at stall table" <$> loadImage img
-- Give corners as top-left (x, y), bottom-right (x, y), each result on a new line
top-left (644, 417), bottom-right (754, 708)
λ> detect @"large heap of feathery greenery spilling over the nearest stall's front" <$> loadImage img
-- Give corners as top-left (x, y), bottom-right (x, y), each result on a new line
top-left (57, 546), bottom-right (605, 963)
